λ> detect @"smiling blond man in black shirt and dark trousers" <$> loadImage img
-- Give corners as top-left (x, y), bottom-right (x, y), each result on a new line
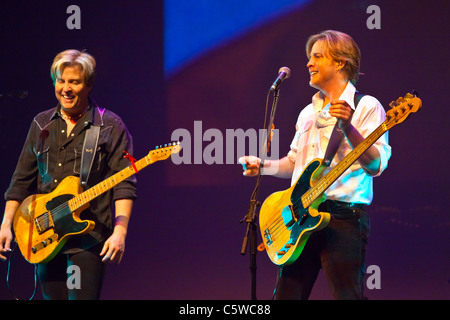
top-left (0, 50), bottom-right (136, 300)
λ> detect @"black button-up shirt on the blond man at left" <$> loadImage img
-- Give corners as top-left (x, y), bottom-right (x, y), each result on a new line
top-left (5, 102), bottom-right (136, 252)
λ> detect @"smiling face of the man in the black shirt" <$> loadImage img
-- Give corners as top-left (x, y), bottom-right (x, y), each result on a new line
top-left (55, 65), bottom-right (91, 116)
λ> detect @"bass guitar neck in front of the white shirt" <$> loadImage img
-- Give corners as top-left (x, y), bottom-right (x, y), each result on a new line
top-left (301, 119), bottom-right (393, 208)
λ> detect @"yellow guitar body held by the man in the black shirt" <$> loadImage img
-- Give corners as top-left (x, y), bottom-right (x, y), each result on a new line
top-left (13, 176), bottom-right (95, 263)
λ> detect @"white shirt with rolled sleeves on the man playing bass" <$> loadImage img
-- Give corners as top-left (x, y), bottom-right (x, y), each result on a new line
top-left (288, 82), bottom-right (391, 204)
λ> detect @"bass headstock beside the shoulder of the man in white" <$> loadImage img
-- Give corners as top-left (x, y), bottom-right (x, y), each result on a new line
top-left (386, 91), bottom-right (422, 127)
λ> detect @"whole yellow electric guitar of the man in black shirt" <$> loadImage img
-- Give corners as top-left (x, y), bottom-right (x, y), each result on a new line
top-left (13, 143), bottom-right (181, 263)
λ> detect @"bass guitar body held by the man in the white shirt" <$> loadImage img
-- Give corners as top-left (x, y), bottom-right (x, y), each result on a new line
top-left (259, 159), bottom-right (330, 265)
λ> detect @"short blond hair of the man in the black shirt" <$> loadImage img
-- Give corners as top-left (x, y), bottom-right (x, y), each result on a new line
top-left (50, 49), bottom-right (96, 87)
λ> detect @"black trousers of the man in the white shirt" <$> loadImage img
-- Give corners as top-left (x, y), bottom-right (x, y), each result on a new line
top-left (274, 200), bottom-right (370, 300)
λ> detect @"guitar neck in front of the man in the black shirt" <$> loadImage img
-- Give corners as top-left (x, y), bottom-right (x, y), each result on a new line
top-left (68, 156), bottom-right (153, 211)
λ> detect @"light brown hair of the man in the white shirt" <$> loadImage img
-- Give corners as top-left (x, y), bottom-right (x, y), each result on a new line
top-left (306, 30), bottom-right (361, 84)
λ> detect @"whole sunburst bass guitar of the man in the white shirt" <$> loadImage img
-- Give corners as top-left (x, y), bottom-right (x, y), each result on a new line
top-left (259, 93), bottom-right (422, 265)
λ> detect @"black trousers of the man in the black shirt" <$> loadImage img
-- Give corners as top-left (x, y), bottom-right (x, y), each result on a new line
top-left (37, 243), bottom-right (105, 300)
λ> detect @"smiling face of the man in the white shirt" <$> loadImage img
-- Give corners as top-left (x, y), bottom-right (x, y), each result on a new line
top-left (306, 40), bottom-right (343, 91)
